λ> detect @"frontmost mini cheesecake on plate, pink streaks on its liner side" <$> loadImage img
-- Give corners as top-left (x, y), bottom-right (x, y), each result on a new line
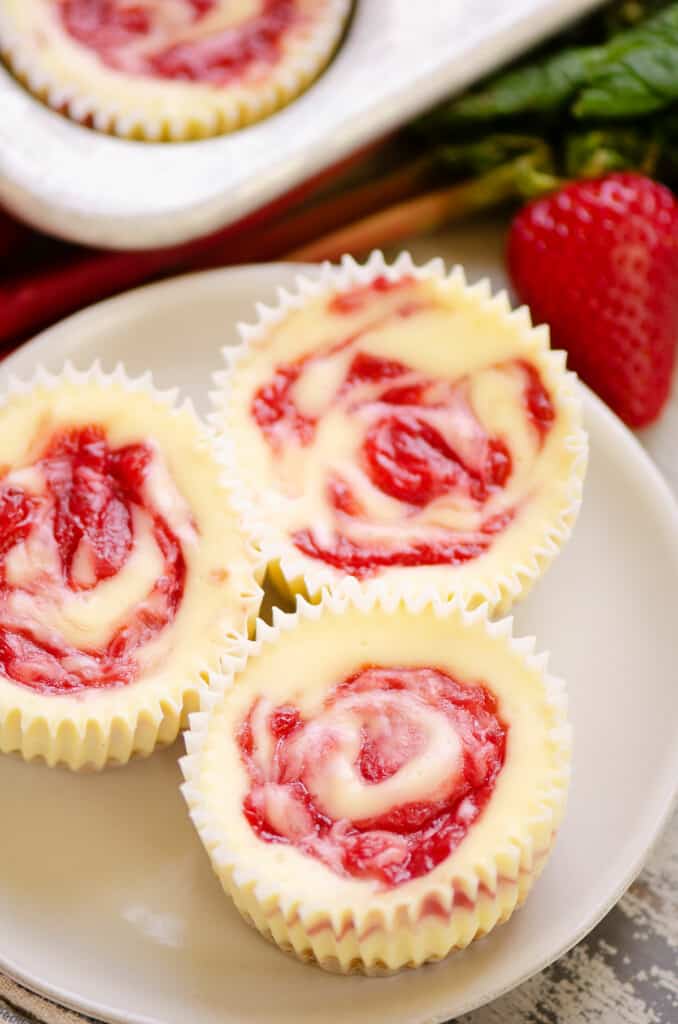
top-left (182, 585), bottom-right (569, 974)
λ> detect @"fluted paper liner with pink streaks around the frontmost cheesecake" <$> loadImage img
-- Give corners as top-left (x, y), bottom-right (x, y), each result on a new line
top-left (180, 581), bottom-right (571, 974)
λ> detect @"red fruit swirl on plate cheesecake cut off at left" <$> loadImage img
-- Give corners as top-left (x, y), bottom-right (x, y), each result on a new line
top-left (0, 426), bottom-right (186, 694)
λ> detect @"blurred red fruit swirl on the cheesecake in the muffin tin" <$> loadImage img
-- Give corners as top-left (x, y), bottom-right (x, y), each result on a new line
top-left (59, 0), bottom-right (299, 86)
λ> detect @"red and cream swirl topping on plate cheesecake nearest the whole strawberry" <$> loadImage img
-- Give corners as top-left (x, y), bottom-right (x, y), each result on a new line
top-left (251, 278), bottom-right (555, 577)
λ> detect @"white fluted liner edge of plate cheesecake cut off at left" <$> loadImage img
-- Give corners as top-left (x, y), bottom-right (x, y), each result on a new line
top-left (0, 362), bottom-right (263, 770)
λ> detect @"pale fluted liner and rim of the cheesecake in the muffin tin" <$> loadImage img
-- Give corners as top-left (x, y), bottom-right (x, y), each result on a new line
top-left (0, 0), bottom-right (351, 142)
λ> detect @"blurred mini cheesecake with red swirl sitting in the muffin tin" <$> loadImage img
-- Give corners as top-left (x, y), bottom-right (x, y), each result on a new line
top-left (0, 0), bottom-right (350, 140)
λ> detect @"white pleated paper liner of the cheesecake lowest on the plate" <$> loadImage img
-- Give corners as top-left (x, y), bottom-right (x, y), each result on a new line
top-left (180, 581), bottom-right (571, 975)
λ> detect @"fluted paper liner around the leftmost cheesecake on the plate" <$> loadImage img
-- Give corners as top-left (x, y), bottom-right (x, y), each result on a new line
top-left (0, 364), bottom-right (263, 769)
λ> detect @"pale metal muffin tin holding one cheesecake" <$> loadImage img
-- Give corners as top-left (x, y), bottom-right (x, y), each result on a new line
top-left (0, 0), bottom-right (601, 249)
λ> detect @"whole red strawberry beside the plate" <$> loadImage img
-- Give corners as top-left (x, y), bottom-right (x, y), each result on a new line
top-left (508, 172), bottom-right (678, 427)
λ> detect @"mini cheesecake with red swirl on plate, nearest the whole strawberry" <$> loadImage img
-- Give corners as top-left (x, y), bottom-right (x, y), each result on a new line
top-left (214, 252), bottom-right (586, 608)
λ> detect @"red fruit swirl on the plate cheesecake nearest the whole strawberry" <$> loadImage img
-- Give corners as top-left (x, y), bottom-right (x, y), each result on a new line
top-left (251, 278), bottom-right (555, 577)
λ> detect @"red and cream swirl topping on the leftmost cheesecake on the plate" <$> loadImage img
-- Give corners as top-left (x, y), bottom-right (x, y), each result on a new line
top-left (0, 425), bottom-right (197, 694)
